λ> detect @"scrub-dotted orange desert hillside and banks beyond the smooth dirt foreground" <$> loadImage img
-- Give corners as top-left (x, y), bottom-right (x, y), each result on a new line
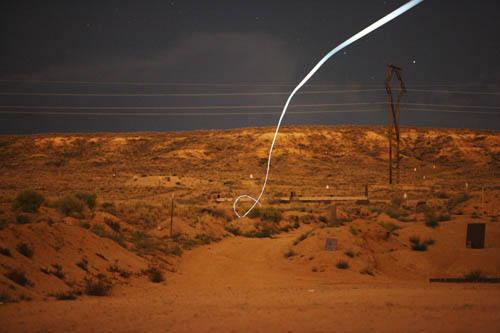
top-left (0, 126), bottom-right (500, 322)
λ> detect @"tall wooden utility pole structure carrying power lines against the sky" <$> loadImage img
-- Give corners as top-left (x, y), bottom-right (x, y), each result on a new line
top-left (385, 64), bottom-right (406, 184)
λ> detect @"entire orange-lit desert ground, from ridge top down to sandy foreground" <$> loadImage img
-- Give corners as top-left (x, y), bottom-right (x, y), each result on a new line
top-left (0, 126), bottom-right (500, 332)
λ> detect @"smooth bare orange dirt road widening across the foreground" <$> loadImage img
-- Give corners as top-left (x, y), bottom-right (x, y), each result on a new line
top-left (0, 230), bottom-right (500, 332)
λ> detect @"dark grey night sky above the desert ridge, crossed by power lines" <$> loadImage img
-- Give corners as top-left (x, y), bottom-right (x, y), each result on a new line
top-left (0, 0), bottom-right (500, 134)
